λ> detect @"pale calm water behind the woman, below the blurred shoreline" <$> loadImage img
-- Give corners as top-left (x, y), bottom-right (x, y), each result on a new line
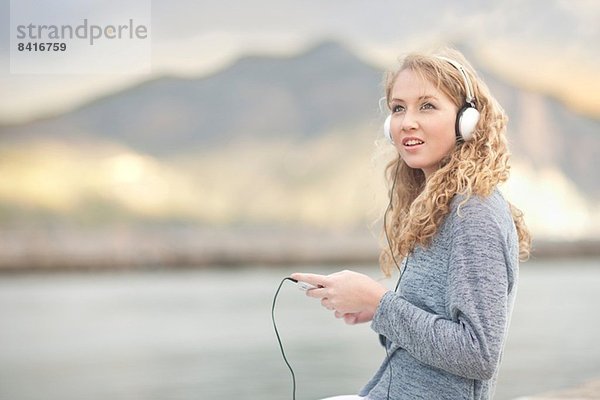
top-left (0, 260), bottom-right (600, 400)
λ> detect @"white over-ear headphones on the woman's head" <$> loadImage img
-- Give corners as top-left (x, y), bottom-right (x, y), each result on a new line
top-left (383, 56), bottom-right (480, 143)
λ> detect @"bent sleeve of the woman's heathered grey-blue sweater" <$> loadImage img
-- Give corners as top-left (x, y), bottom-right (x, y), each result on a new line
top-left (372, 198), bottom-right (509, 380)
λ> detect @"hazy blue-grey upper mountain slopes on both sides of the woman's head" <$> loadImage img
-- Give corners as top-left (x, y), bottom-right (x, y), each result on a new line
top-left (0, 42), bottom-right (600, 198)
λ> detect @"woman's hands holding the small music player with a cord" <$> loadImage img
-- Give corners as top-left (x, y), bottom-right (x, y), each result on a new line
top-left (291, 270), bottom-right (387, 324)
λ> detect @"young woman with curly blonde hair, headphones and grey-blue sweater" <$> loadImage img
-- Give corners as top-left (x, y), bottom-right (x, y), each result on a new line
top-left (292, 49), bottom-right (530, 400)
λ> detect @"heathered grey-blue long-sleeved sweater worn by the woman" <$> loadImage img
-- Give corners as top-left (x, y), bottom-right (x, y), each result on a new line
top-left (359, 190), bottom-right (519, 400)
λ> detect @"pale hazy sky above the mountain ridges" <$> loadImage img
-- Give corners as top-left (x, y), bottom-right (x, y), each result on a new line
top-left (0, 0), bottom-right (600, 123)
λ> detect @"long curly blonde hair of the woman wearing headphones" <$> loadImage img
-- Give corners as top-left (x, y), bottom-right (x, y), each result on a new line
top-left (379, 49), bottom-right (531, 276)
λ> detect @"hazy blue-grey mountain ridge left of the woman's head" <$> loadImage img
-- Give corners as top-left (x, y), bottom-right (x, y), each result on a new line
top-left (0, 43), bottom-right (382, 156)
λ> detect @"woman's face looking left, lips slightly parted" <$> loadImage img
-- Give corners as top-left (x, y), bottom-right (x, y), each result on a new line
top-left (390, 69), bottom-right (458, 178)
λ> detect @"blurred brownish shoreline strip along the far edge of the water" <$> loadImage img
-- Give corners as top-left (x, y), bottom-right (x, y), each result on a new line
top-left (0, 227), bottom-right (600, 272)
